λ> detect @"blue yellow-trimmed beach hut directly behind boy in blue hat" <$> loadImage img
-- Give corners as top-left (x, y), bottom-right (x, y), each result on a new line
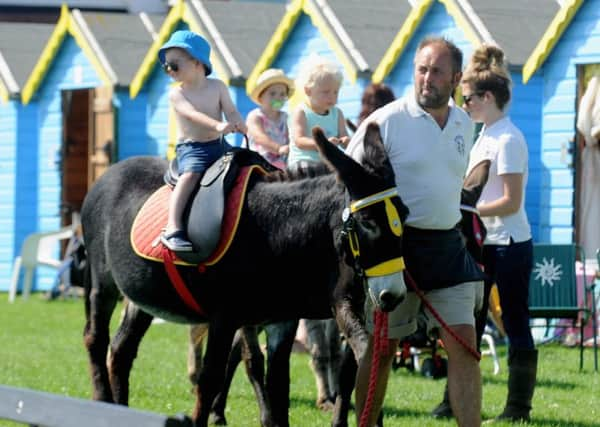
top-left (128, 0), bottom-right (285, 156)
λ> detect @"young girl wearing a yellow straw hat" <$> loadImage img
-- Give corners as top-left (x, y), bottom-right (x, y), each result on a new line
top-left (246, 68), bottom-right (294, 169)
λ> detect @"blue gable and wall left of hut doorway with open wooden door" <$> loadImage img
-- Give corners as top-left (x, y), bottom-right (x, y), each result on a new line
top-left (10, 35), bottom-right (102, 290)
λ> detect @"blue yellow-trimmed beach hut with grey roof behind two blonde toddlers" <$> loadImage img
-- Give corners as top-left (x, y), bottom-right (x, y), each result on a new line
top-left (246, 0), bottom-right (401, 124)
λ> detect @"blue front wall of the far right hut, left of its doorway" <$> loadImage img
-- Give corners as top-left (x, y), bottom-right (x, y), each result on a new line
top-left (536, 0), bottom-right (600, 243)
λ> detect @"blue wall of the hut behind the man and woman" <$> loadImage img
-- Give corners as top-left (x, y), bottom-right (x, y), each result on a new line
top-left (385, 2), bottom-right (542, 240)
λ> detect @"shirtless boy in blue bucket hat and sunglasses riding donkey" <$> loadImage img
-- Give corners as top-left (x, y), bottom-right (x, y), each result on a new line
top-left (158, 31), bottom-right (246, 252)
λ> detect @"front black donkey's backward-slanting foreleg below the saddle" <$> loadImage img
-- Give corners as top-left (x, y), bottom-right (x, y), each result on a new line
top-left (192, 313), bottom-right (237, 427)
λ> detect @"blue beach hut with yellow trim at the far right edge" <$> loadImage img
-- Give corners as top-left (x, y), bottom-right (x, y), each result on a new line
top-left (523, 0), bottom-right (600, 252)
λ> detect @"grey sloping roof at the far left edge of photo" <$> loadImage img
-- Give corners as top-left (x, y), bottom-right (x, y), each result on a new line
top-left (0, 22), bottom-right (54, 101)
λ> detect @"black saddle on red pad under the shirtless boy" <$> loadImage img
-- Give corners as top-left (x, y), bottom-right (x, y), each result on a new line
top-left (164, 147), bottom-right (278, 264)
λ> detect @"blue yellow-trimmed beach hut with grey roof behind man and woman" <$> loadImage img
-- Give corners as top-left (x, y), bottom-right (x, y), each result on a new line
top-left (373, 0), bottom-right (560, 240)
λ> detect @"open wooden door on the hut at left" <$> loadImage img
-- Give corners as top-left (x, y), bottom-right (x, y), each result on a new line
top-left (88, 87), bottom-right (116, 188)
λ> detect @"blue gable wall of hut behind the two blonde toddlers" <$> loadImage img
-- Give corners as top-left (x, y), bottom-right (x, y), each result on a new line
top-left (271, 13), bottom-right (369, 127)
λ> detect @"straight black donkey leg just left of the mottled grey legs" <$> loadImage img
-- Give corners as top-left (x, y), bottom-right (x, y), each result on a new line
top-left (265, 320), bottom-right (298, 427)
